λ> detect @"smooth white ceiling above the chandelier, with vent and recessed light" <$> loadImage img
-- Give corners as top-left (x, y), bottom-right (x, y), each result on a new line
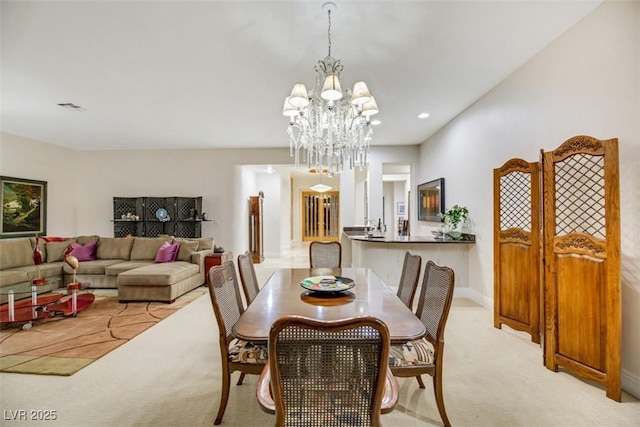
top-left (0, 0), bottom-right (601, 150)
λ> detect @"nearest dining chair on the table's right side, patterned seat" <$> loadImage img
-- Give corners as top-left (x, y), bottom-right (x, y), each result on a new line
top-left (389, 260), bottom-right (455, 426)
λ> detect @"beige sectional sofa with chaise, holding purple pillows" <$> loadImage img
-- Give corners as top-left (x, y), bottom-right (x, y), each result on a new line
top-left (0, 236), bottom-right (214, 303)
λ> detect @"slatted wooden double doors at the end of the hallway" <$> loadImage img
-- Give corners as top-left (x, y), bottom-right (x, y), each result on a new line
top-left (300, 191), bottom-right (340, 242)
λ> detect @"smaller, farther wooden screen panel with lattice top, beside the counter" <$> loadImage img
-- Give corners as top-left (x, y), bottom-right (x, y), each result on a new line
top-left (493, 159), bottom-right (541, 343)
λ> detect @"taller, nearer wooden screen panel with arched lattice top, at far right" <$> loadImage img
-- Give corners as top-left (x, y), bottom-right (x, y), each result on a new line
top-left (542, 136), bottom-right (622, 401)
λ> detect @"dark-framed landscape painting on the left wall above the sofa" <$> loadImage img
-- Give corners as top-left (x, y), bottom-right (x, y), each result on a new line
top-left (0, 176), bottom-right (47, 239)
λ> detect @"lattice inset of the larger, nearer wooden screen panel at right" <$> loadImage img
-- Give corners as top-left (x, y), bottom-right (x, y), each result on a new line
top-left (555, 154), bottom-right (606, 239)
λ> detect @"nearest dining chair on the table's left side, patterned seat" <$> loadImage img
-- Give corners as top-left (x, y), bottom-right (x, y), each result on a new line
top-left (208, 260), bottom-right (268, 424)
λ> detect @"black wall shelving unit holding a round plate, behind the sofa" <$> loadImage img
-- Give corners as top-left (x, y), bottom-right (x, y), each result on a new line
top-left (113, 197), bottom-right (202, 238)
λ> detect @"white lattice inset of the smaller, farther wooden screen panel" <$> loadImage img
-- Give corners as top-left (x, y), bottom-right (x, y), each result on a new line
top-left (500, 171), bottom-right (531, 231)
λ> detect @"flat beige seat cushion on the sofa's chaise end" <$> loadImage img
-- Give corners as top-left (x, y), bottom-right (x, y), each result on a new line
top-left (118, 261), bottom-right (200, 286)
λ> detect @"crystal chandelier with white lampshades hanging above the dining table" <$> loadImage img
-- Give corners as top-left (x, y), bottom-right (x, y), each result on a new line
top-left (282, 2), bottom-right (378, 176)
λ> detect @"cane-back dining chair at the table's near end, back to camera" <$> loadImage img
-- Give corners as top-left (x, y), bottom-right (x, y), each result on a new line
top-left (257, 316), bottom-right (398, 427)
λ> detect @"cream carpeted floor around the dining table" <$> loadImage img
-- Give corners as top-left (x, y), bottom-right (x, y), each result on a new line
top-left (0, 247), bottom-right (640, 427)
